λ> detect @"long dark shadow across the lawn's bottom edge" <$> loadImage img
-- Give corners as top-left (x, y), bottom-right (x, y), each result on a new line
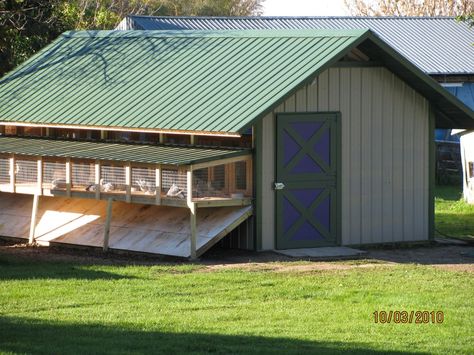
top-left (0, 317), bottom-right (419, 355)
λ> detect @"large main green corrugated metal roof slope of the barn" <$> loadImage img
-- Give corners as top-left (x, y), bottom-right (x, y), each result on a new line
top-left (0, 30), bottom-right (368, 133)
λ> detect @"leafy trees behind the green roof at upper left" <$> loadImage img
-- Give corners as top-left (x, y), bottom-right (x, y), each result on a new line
top-left (0, 0), bottom-right (264, 77)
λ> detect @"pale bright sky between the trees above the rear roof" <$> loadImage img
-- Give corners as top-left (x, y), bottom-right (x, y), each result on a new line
top-left (263, 0), bottom-right (349, 16)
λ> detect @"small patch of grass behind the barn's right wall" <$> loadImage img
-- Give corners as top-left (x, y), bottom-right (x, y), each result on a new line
top-left (435, 185), bottom-right (474, 241)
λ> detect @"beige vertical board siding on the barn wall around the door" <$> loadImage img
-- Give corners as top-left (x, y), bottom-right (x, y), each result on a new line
top-left (261, 67), bottom-right (429, 250)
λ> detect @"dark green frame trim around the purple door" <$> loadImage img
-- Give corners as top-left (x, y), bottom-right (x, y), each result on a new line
top-left (273, 111), bottom-right (342, 250)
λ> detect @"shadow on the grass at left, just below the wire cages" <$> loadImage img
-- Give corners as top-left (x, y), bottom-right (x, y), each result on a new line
top-left (0, 255), bottom-right (134, 281)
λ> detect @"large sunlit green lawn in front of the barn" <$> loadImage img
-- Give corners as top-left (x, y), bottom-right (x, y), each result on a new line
top-left (0, 254), bottom-right (474, 354)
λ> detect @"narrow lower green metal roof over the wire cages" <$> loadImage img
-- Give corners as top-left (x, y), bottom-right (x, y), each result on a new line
top-left (0, 137), bottom-right (249, 165)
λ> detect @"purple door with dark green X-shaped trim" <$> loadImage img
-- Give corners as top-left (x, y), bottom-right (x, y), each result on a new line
top-left (275, 113), bottom-right (338, 249)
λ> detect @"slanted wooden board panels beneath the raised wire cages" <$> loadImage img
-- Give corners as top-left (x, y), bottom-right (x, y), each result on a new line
top-left (0, 193), bottom-right (252, 257)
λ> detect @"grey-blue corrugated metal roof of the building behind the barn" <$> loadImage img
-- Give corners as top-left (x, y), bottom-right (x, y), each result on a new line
top-left (119, 16), bottom-right (474, 74)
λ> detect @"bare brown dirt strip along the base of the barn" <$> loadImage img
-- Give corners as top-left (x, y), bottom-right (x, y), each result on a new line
top-left (0, 239), bottom-right (474, 273)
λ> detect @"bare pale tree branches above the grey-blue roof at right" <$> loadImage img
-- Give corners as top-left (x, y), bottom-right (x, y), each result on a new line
top-left (344, 0), bottom-right (474, 16)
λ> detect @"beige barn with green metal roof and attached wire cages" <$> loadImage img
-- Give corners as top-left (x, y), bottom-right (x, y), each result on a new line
top-left (0, 29), bottom-right (474, 258)
